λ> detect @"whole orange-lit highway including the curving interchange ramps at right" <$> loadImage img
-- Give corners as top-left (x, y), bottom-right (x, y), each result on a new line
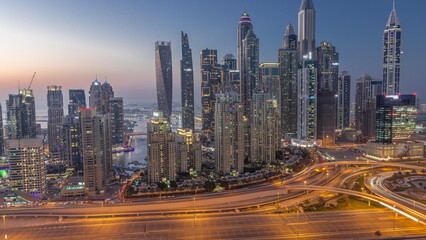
top-left (0, 148), bottom-right (426, 239)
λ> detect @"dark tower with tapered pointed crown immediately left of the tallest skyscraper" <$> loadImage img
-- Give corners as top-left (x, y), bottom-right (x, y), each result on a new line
top-left (278, 24), bottom-right (298, 136)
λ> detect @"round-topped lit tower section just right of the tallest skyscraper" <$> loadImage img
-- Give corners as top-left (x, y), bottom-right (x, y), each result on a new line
top-left (317, 42), bottom-right (339, 93)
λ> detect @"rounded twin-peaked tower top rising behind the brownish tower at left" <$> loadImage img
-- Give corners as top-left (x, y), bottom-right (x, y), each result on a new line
top-left (89, 79), bottom-right (114, 114)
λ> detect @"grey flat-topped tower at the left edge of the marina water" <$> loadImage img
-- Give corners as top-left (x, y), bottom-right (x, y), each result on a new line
top-left (109, 97), bottom-right (124, 144)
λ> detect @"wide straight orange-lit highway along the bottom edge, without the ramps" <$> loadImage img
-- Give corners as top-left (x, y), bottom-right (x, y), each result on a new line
top-left (6, 208), bottom-right (426, 240)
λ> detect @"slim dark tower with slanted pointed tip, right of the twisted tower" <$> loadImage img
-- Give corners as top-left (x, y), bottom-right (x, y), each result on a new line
top-left (180, 32), bottom-right (194, 129)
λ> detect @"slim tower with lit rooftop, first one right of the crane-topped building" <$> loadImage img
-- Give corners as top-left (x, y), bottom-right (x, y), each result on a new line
top-left (47, 85), bottom-right (64, 154)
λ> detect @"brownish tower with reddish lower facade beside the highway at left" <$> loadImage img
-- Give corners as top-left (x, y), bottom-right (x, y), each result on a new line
top-left (80, 108), bottom-right (112, 195)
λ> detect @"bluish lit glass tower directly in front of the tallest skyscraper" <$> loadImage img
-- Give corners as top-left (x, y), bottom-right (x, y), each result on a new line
top-left (297, 60), bottom-right (317, 140)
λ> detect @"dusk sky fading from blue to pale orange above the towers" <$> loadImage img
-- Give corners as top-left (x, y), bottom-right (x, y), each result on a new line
top-left (0, 0), bottom-right (426, 113)
